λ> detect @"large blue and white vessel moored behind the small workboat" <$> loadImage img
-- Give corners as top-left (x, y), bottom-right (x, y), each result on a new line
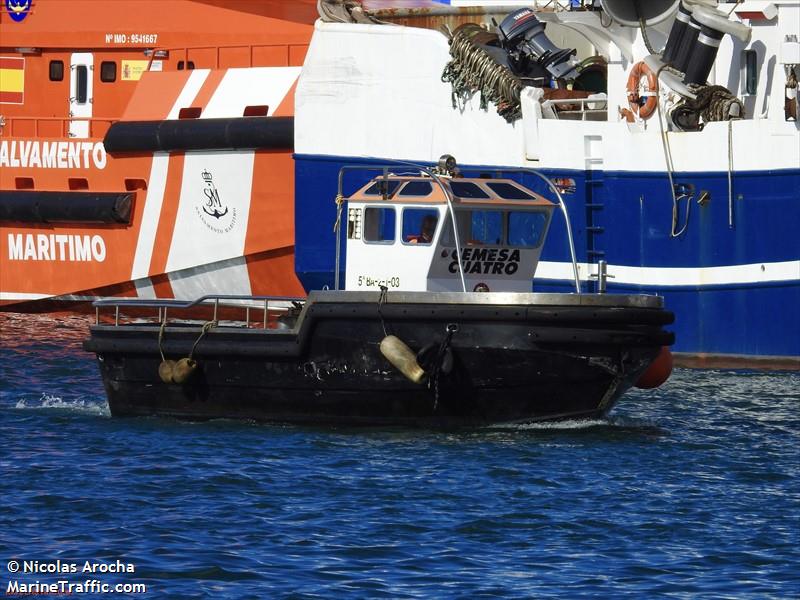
top-left (295, 0), bottom-right (800, 369)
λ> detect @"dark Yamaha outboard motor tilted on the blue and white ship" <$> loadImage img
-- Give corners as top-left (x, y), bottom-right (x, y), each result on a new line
top-left (497, 8), bottom-right (579, 79)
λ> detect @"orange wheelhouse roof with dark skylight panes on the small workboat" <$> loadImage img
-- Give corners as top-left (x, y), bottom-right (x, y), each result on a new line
top-left (348, 174), bottom-right (554, 208)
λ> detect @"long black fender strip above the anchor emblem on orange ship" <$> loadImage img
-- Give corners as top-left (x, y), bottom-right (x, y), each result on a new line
top-left (103, 117), bottom-right (294, 155)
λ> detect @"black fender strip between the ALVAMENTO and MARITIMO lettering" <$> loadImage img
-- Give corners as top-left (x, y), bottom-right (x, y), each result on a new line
top-left (0, 190), bottom-right (133, 224)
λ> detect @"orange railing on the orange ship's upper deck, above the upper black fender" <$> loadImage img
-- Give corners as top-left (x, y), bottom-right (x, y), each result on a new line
top-left (147, 44), bottom-right (308, 71)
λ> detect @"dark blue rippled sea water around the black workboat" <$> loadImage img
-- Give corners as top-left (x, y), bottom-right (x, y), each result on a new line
top-left (0, 315), bottom-right (800, 598)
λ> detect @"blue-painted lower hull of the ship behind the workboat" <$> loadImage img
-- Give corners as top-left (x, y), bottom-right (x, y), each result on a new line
top-left (295, 155), bottom-right (800, 368)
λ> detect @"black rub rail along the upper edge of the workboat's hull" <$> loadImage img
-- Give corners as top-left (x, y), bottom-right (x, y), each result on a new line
top-left (84, 292), bottom-right (674, 357)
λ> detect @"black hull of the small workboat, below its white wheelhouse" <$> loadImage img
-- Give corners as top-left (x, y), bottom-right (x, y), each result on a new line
top-left (85, 294), bottom-right (672, 427)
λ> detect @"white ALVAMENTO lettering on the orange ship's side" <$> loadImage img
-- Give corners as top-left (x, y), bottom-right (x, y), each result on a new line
top-left (0, 140), bottom-right (108, 169)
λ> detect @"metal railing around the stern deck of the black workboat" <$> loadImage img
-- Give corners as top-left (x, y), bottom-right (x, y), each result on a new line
top-left (92, 294), bottom-right (306, 329)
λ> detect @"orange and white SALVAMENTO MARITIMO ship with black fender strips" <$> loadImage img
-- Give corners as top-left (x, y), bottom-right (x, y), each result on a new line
top-left (0, 0), bottom-right (317, 310)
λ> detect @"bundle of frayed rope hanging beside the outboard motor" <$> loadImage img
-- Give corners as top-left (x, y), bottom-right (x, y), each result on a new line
top-left (442, 23), bottom-right (524, 123)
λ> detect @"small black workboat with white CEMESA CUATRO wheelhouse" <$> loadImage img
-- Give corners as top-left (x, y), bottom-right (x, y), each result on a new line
top-left (84, 159), bottom-right (673, 427)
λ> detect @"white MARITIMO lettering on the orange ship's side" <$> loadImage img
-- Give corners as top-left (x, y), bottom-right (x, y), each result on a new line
top-left (8, 233), bottom-right (106, 262)
